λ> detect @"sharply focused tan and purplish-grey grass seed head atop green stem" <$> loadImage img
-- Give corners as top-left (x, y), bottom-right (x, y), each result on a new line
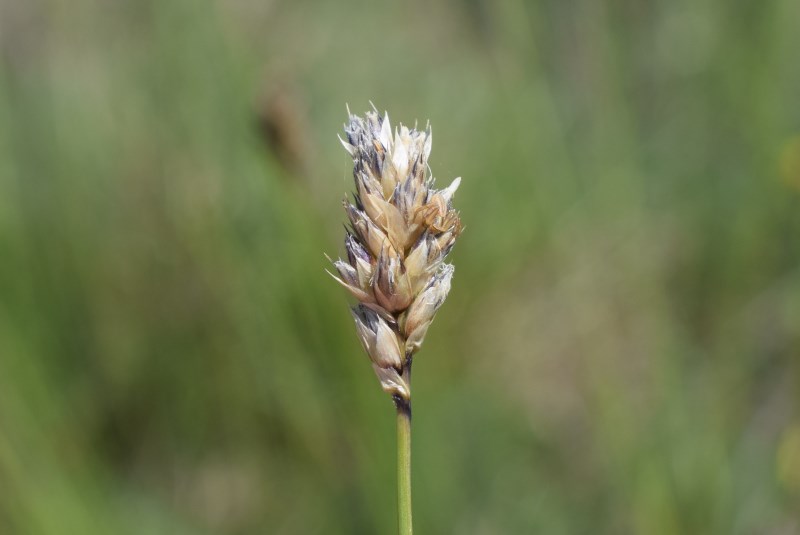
top-left (332, 110), bottom-right (461, 403)
